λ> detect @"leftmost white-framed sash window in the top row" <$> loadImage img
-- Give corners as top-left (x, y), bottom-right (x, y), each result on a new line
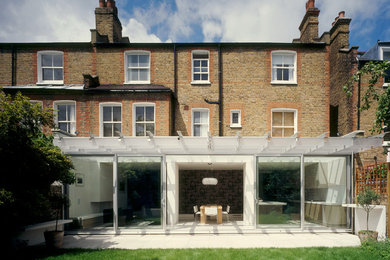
top-left (37, 51), bottom-right (64, 84)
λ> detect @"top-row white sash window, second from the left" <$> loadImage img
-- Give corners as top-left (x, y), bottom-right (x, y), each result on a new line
top-left (125, 51), bottom-right (150, 84)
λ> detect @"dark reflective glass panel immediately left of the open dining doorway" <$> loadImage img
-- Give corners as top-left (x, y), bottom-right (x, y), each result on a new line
top-left (118, 157), bottom-right (162, 228)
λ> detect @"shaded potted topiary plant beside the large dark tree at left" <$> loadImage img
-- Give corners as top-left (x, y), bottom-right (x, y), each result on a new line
top-left (44, 192), bottom-right (70, 249)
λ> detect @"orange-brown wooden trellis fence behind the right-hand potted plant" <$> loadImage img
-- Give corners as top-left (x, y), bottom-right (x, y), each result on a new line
top-left (355, 163), bottom-right (390, 236)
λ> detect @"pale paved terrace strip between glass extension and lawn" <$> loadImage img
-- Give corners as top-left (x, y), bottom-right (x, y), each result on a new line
top-left (63, 233), bottom-right (360, 249)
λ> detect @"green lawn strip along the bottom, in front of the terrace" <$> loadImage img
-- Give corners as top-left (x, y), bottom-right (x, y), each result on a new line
top-left (9, 242), bottom-right (390, 260)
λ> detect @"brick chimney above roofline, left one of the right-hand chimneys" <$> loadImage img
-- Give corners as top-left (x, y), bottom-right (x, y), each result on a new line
top-left (299, 0), bottom-right (320, 43)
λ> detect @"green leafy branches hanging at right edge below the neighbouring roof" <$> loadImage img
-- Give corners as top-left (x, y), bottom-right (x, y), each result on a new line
top-left (344, 60), bottom-right (390, 132)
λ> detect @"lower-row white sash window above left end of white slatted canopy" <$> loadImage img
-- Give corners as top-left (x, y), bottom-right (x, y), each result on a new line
top-left (53, 100), bottom-right (76, 134)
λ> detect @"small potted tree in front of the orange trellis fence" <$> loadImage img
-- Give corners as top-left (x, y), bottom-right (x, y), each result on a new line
top-left (357, 187), bottom-right (379, 242)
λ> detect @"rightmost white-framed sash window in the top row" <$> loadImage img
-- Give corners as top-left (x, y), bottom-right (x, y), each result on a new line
top-left (271, 51), bottom-right (297, 84)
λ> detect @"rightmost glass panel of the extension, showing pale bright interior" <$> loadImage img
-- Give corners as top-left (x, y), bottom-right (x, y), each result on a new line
top-left (304, 157), bottom-right (347, 228)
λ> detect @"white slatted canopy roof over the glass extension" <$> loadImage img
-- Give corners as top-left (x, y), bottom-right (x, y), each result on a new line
top-left (54, 134), bottom-right (383, 156)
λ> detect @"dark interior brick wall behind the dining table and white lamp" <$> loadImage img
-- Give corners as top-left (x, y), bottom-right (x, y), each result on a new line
top-left (179, 170), bottom-right (243, 214)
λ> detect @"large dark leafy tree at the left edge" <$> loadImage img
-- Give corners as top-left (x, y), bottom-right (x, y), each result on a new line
top-left (0, 91), bottom-right (75, 246)
